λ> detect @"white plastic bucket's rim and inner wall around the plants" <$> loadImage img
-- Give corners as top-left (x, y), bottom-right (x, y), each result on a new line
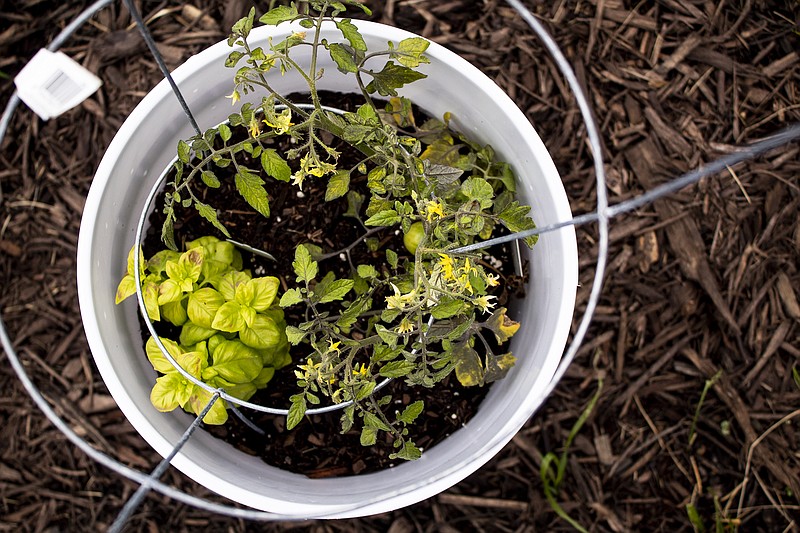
top-left (78, 22), bottom-right (578, 517)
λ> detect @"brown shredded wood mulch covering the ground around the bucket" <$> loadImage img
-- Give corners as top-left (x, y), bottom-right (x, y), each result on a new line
top-left (0, 0), bottom-right (800, 533)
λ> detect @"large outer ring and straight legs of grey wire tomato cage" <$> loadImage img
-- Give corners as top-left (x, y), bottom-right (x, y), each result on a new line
top-left (0, 0), bottom-right (800, 531)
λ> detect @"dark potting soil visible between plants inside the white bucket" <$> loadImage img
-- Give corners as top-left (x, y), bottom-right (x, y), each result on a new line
top-left (143, 93), bottom-right (522, 477)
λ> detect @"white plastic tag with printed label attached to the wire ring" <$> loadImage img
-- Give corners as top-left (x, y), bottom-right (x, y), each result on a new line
top-left (14, 48), bottom-right (103, 120)
